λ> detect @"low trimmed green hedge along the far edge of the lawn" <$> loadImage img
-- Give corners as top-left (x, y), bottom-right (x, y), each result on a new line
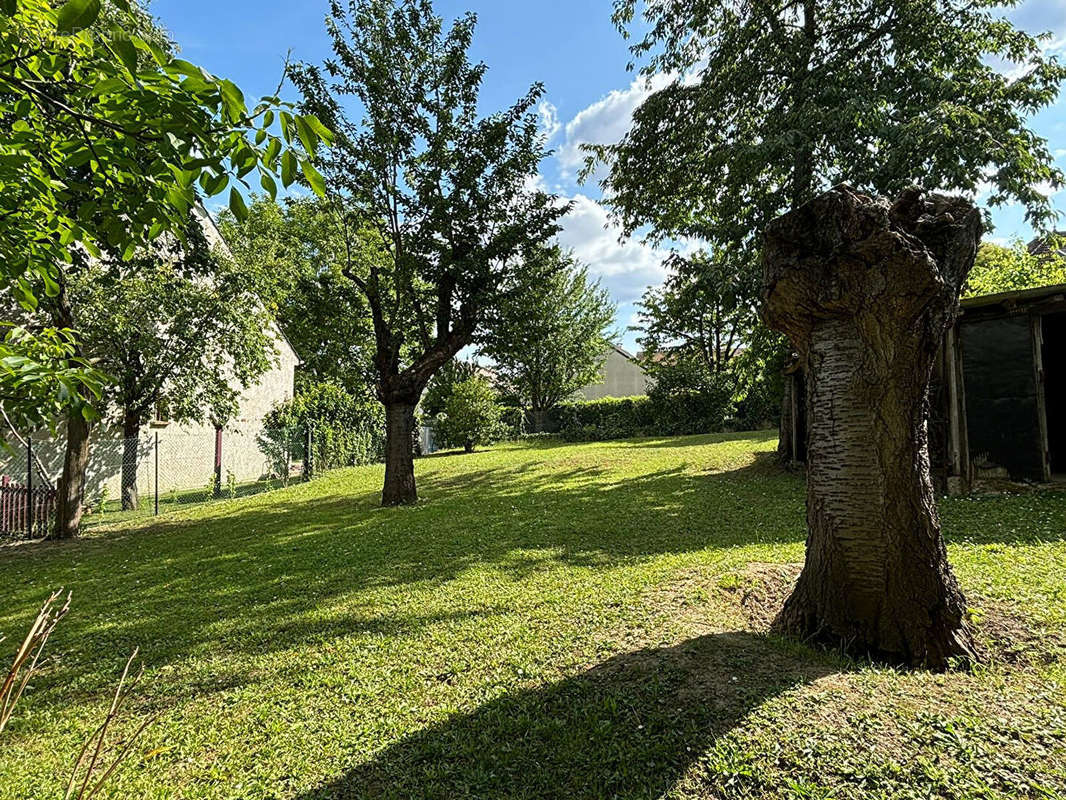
top-left (545, 391), bottom-right (733, 442)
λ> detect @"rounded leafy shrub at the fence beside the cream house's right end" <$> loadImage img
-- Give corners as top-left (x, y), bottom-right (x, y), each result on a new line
top-left (259, 381), bottom-right (385, 477)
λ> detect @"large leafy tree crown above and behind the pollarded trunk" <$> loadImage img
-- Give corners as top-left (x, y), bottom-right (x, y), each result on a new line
top-left (592, 0), bottom-right (1066, 462)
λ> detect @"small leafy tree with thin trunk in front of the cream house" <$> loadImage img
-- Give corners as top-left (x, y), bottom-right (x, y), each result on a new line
top-left (68, 214), bottom-right (277, 510)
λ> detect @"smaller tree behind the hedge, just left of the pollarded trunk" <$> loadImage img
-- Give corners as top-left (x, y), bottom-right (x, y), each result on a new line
top-left (634, 250), bottom-right (759, 398)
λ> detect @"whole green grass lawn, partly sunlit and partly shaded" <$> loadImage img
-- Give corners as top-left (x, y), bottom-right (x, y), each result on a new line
top-left (0, 433), bottom-right (1066, 800)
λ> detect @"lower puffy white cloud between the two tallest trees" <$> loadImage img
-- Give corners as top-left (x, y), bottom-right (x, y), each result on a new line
top-left (559, 194), bottom-right (669, 303)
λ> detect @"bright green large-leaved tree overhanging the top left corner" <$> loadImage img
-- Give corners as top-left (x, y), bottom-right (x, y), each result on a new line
top-left (0, 0), bottom-right (328, 538)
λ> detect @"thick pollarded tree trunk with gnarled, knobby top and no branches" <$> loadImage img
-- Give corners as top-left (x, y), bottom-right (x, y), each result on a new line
top-left (764, 186), bottom-right (981, 669)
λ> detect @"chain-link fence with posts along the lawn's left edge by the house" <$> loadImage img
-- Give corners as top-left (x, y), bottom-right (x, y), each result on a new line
top-left (0, 427), bottom-right (334, 540)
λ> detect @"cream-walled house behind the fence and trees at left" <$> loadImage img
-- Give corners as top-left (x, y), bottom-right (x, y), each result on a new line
top-left (0, 212), bottom-right (300, 503)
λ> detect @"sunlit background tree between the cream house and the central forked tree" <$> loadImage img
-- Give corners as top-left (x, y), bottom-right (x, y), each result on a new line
top-left (219, 196), bottom-right (384, 398)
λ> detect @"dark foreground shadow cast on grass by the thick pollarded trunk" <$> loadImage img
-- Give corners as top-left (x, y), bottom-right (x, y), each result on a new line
top-left (287, 631), bottom-right (841, 800)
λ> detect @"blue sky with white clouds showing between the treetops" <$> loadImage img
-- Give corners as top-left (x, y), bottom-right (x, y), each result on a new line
top-left (150, 0), bottom-right (1066, 349)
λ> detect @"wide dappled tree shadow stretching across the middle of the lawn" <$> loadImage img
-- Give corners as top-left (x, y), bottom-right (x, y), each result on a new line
top-left (0, 460), bottom-right (803, 688)
